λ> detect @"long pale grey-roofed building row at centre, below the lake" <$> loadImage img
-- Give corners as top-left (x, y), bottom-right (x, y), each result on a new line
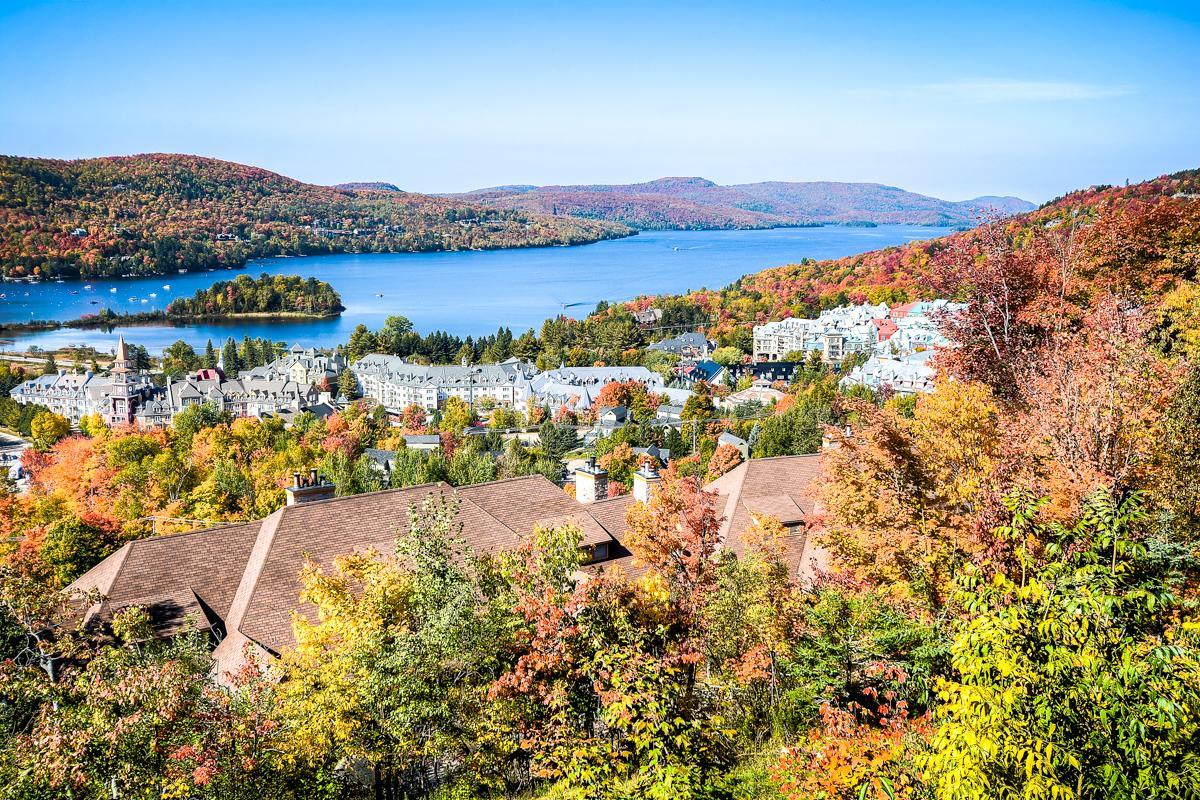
top-left (350, 354), bottom-right (690, 414)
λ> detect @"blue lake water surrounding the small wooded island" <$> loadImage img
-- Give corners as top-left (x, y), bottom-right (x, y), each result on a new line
top-left (0, 225), bottom-right (949, 353)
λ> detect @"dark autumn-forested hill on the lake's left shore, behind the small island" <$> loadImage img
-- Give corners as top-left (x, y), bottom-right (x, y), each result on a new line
top-left (0, 154), bottom-right (631, 277)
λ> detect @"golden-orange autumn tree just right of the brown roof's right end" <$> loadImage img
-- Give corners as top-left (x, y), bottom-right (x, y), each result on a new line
top-left (820, 383), bottom-right (1001, 607)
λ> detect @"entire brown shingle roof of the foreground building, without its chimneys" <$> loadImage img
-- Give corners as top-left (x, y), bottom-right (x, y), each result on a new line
top-left (73, 456), bottom-right (818, 669)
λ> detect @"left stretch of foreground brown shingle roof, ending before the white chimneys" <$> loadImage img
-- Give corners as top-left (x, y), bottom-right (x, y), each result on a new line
top-left (72, 475), bottom-right (628, 666)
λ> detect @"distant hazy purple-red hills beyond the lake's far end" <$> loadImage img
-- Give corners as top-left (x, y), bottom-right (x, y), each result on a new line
top-left (448, 178), bottom-right (1033, 229)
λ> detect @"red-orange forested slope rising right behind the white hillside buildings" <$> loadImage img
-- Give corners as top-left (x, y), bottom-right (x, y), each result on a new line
top-left (606, 170), bottom-right (1200, 333)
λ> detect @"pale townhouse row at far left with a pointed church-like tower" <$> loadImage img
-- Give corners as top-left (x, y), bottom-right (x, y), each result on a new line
top-left (11, 338), bottom-right (320, 428)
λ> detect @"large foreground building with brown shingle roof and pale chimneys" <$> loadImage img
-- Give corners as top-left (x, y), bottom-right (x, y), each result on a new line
top-left (71, 455), bottom-right (828, 675)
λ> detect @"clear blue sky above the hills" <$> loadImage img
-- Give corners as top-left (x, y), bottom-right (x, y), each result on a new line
top-left (0, 0), bottom-right (1200, 200)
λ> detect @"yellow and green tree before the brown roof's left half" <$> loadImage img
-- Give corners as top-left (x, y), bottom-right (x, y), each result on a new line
top-left (281, 495), bottom-right (503, 789)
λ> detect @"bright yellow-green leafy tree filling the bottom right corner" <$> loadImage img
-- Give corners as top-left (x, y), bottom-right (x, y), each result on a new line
top-left (924, 492), bottom-right (1200, 800)
